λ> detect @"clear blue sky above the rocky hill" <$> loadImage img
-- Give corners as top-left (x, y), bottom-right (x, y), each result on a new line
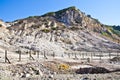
top-left (0, 0), bottom-right (120, 25)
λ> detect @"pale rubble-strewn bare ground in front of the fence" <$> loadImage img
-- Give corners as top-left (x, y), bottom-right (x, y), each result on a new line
top-left (0, 55), bottom-right (120, 80)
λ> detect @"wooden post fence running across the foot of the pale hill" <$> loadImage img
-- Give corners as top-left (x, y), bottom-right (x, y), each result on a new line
top-left (0, 50), bottom-right (120, 64)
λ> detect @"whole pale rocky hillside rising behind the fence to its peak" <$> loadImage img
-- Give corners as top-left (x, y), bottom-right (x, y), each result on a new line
top-left (0, 7), bottom-right (120, 55)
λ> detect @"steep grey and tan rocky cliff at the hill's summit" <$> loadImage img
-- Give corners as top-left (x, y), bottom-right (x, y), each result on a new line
top-left (43, 7), bottom-right (104, 32)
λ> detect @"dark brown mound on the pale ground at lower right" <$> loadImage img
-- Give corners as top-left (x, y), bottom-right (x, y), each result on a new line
top-left (76, 67), bottom-right (110, 74)
